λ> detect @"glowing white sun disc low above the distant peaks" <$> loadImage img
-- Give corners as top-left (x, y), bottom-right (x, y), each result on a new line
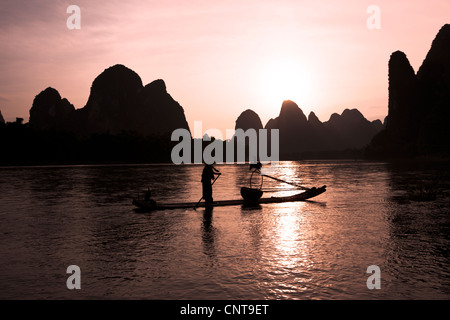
top-left (260, 59), bottom-right (314, 110)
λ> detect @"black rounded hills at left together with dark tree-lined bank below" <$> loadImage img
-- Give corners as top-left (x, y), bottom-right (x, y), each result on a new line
top-left (0, 65), bottom-right (189, 165)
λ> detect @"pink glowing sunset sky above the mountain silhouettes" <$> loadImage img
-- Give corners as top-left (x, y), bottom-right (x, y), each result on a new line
top-left (0, 0), bottom-right (450, 136)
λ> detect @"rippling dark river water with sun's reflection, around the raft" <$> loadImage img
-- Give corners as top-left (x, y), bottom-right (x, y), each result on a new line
top-left (0, 161), bottom-right (450, 299)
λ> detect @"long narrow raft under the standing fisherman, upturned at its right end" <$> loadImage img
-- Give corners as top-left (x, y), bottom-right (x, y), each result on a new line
top-left (133, 186), bottom-right (326, 211)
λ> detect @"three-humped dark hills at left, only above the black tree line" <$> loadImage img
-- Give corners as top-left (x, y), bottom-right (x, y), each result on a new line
top-left (29, 64), bottom-right (189, 135)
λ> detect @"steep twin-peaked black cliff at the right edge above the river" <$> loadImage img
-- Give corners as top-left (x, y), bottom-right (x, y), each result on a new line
top-left (367, 24), bottom-right (450, 158)
